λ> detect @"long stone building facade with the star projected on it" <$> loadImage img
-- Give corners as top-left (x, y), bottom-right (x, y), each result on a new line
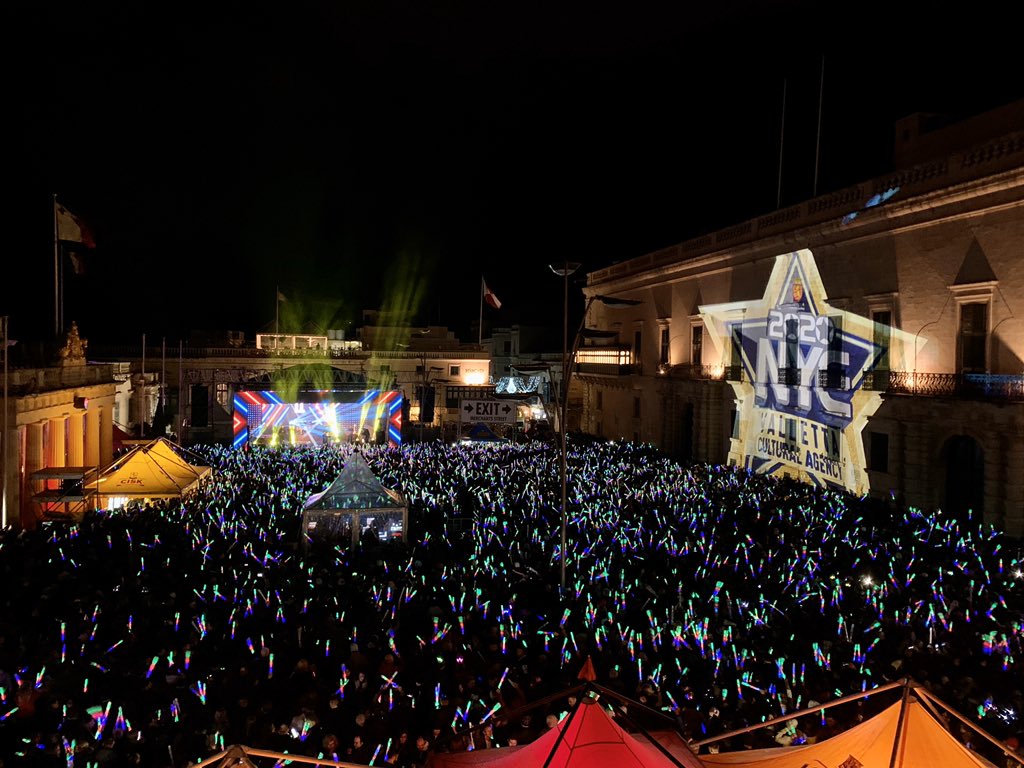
top-left (572, 109), bottom-right (1024, 537)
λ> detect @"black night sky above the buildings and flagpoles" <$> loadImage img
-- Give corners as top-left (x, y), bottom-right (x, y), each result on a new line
top-left (8, 0), bottom-right (1024, 343)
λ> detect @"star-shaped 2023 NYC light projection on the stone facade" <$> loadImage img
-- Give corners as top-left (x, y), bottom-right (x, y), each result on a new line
top-left (700, 250), bottom-right (913, 495)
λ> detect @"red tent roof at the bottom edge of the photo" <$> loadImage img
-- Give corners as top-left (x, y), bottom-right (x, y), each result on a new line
top-left (427, 696), bottom-right (700, 768)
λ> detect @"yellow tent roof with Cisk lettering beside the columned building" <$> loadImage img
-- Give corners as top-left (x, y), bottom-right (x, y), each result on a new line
top-left (89, 437), bottom-right (211, 499)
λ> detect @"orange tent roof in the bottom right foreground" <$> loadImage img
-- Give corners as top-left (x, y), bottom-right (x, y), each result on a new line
top-left (700, 696), bottom-right (991, 768)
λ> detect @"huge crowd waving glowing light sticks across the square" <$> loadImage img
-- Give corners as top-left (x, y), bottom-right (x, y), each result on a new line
top-left (0, 440), bottom-right (1024, 768)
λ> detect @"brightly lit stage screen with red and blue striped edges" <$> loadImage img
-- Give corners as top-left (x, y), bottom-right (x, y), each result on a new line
top-left (232, 389), bottom-right (401, 447)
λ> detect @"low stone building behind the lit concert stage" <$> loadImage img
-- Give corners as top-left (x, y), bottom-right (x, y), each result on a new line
top-left (93, 326), bottom-right (494, 445)
